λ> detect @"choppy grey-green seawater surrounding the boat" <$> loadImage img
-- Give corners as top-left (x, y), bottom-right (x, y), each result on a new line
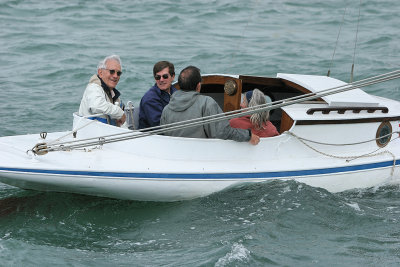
top-left (0, 0), bottom-right (400, 266)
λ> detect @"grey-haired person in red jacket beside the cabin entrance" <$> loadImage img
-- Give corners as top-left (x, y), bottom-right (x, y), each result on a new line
top-left (229, 89), bottom-right (279, 137)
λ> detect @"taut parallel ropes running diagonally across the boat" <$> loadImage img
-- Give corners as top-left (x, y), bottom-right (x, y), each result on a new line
top-left (32, 70), bottom-right (400, 153)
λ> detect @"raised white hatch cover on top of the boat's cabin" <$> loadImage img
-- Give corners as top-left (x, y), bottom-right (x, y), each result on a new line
top-left (277, 73), bottom-right (379, 107)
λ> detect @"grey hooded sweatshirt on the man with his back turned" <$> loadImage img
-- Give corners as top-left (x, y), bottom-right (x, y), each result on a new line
top-left (161, 90), bottom-right (251, 142)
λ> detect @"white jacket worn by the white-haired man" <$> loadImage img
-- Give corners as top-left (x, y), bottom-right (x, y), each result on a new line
top-left (79, 74), bottom-right (124, 119)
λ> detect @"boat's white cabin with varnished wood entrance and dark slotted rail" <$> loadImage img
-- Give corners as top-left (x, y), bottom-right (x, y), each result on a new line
top-left (174, 73), bottom-right (395, 136)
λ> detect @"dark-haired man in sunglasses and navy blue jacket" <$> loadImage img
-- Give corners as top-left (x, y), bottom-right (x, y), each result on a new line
top-left (139, 61), bottom-right (176, 129)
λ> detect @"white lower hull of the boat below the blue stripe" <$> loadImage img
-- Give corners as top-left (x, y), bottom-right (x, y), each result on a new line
top-left (0, 161), bottom-right (398, 201)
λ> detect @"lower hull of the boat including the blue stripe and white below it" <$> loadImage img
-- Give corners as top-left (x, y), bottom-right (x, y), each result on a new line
top-left (0, 161), bottom-right (400, 201)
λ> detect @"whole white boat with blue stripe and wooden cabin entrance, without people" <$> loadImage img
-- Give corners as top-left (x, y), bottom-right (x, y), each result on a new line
top-left (0, 71), bottom-right (400, 201)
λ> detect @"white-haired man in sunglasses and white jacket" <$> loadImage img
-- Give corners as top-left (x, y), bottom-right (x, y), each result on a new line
top-left (78, 55), bottom-right (126, 126)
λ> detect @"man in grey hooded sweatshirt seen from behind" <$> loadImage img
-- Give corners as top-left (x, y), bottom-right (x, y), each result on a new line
top-left (160, 66), bottom-right (260, 145)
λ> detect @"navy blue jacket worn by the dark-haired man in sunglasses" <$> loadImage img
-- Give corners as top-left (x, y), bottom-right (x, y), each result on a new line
top-left (139, 84), bottom-right (176, 129)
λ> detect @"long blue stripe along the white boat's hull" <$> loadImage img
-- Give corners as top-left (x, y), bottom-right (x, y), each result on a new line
top-left (0, 161), bottom-right (398, 180)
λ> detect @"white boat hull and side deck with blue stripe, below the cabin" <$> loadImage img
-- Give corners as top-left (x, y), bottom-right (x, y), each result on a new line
top-left (0, 117), bottom-right (400, 201)
